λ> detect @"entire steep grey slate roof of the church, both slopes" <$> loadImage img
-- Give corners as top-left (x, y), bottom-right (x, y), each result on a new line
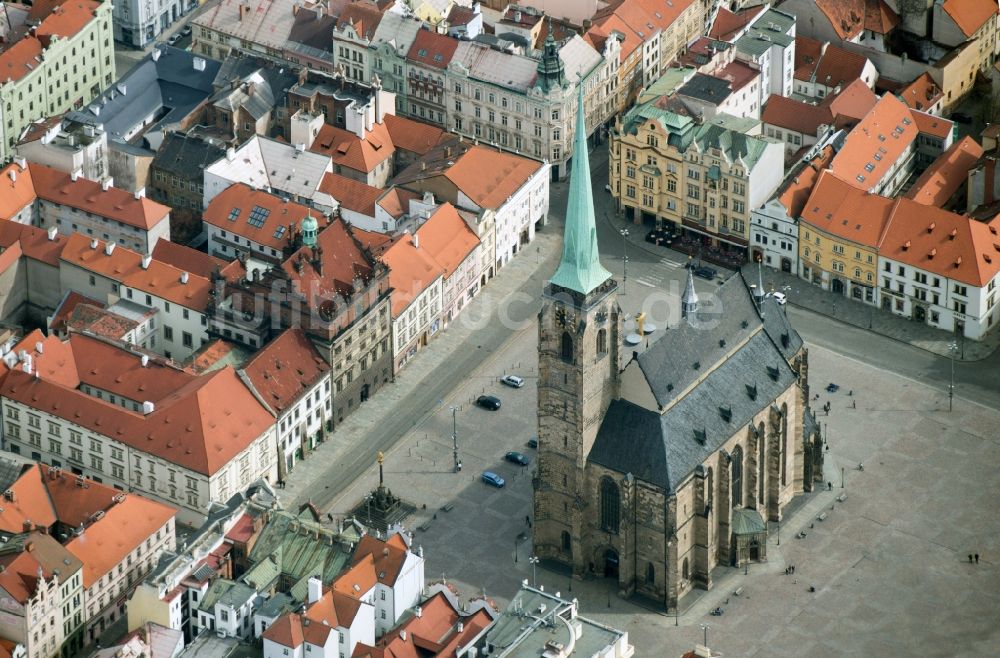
top-left (588, 276), bottom-right (802, 492)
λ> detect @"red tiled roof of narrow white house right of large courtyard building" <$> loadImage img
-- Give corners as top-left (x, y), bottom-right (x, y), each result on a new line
top-left (243, 328), bottom-right (330, 414)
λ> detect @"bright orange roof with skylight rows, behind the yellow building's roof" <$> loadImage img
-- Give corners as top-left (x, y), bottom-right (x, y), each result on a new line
top-left (830, 94), bottom-right (917, 190)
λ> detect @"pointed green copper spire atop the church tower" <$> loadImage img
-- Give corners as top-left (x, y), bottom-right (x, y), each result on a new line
top-left (552, 79), bottom-right (611, 295)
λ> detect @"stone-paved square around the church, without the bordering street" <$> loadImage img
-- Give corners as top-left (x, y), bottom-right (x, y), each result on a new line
top-left (320, 330), bottom-right (1000, 656)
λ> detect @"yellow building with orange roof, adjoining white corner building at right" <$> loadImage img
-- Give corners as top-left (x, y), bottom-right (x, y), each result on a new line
top-left (799, 171), bottom-right (895, 304)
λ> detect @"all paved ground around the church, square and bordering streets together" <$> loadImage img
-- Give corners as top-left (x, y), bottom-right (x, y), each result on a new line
top-left (280, 145), bottom-right (1000, 656)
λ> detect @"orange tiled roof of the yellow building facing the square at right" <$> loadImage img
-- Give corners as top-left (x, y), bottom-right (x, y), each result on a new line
top-left (801, 170), bottom-right (893, 247)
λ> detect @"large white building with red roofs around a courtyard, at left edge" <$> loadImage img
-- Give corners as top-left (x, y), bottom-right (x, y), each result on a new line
top-left (0, 334), bottom-right (277, 520)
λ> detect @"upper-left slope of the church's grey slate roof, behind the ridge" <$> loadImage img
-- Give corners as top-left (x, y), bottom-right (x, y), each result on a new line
top-left (638, 276), bottom-right (761, 407)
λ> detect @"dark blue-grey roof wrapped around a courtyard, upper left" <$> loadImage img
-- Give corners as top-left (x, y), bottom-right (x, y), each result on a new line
top-left (67, 46), bottom-right (220, 147)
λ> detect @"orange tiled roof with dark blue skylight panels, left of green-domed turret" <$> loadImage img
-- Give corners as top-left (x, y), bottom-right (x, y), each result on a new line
top-left (202, 183), bottom-right (314, 252)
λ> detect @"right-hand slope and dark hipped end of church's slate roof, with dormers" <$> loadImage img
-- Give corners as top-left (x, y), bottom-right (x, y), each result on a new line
top-left (588, 331), bottom-right (796, 492)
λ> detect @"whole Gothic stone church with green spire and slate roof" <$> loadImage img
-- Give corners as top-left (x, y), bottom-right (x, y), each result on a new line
top-left (533, 88), bottom-right (822, 610)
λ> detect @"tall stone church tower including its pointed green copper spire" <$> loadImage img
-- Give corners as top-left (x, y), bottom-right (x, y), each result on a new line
top-left (533, 84), bottom-right (621, 575)
